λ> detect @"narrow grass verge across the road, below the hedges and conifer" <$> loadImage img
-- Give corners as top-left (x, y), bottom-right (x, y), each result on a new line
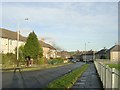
top-left (2, 63), bottom-right (71, 72)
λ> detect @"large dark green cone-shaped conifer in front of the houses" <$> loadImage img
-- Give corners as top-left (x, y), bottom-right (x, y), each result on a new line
top-left (24, 31), bottom-right (42, 59)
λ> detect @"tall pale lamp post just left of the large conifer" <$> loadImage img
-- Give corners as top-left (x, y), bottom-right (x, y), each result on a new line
top-left (17, 18), bottom-right (28, 67)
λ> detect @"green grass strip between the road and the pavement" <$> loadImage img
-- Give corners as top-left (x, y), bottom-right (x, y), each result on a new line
top-left (47, 64), bottom-right (89, 89)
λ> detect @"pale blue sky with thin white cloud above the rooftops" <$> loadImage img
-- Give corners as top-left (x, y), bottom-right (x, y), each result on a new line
top-left (0, 2), bottom-right (118, 51)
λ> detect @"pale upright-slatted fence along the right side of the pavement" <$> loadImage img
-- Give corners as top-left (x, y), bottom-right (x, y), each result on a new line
top-left (94, 60), bottom-right (120, 90)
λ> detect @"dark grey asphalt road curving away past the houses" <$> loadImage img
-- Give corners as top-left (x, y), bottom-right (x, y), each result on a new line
top-left (2, 62), bottom-right (84, 88)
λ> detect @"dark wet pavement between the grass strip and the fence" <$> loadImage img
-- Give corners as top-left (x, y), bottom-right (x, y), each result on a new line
top-left (72, 63), bottom-right (103, 90)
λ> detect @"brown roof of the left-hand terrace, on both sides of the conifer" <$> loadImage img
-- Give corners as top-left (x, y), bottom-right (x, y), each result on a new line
top-left (0, 28), bottom-right (56, 50)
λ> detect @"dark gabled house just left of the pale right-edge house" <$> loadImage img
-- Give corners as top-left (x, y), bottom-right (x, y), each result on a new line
top-left (95, 48), bottom-right (107, 59)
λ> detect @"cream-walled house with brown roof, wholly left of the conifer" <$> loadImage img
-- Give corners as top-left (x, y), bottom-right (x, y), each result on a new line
top-left (0, 28), bottom-right (27, 54)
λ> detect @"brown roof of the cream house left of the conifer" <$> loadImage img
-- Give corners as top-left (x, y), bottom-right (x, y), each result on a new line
top-left (0, 28), bottom-right (27, 42)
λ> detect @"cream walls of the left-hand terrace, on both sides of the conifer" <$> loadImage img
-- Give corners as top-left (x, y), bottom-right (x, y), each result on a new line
top-left (0, 37), bottom-right (56, 59)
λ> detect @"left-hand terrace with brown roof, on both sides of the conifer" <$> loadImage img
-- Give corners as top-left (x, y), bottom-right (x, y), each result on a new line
top-left (0, 28), bottom-right (56, 59)
